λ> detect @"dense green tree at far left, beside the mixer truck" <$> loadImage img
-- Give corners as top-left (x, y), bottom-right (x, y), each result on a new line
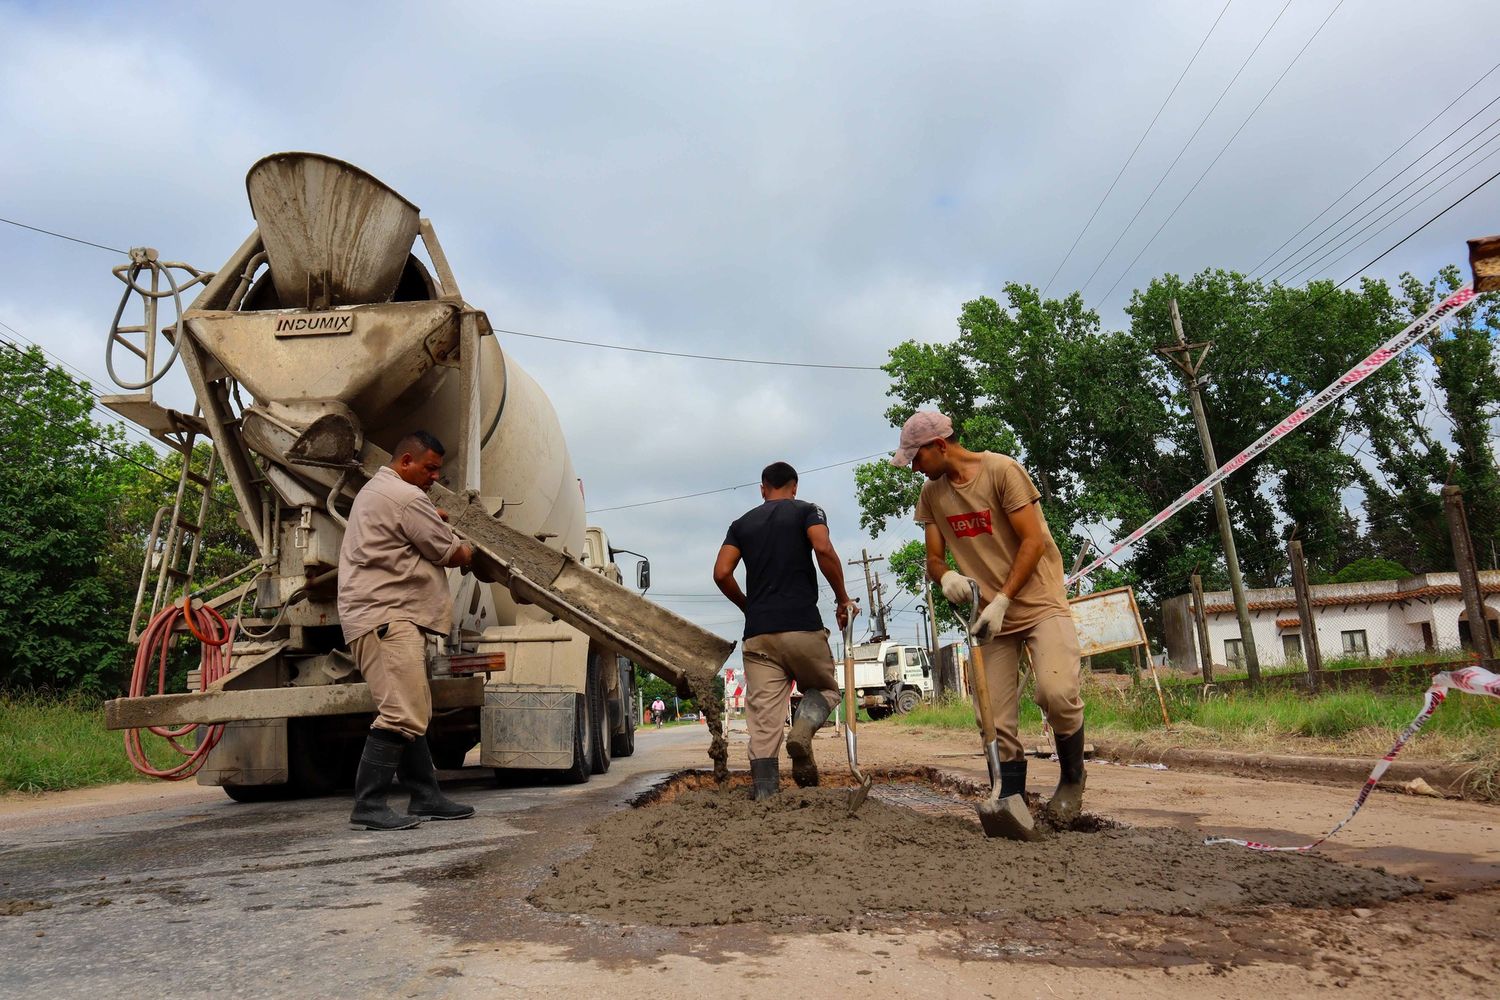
top-left (0, 348), bottom-right (153, 693)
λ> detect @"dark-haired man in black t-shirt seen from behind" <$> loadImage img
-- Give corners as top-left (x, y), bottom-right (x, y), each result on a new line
top-left (714, 462), bottom-right (858, 799)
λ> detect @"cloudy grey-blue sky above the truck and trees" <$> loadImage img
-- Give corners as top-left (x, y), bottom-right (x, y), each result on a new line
top-left (0, 0), bottom-right (1500, 665)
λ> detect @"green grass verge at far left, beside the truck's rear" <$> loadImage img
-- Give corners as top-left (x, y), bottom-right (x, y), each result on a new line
top-left (0, 694), bottom-right (177, 795)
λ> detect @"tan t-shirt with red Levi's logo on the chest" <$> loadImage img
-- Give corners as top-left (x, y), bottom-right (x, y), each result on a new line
top-left (915, 451), bottom-right (1073, 636)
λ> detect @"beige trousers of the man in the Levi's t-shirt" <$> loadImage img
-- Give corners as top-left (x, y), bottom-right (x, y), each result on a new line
top-left (980, 615), bottom-right (1083, 760)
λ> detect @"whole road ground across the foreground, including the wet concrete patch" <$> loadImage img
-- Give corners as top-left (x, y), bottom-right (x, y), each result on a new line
top-left (0, 726), bottom-right (1500, 1000)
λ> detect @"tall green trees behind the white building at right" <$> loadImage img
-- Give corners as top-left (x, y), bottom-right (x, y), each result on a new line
top-left (855, 268), bottom-right (1500, 632)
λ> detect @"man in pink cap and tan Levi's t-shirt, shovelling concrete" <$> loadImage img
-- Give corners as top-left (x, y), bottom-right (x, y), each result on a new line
top-left (891, 411), bottom-right (1085, 822)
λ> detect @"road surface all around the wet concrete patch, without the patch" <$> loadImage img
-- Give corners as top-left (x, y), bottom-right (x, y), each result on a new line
top-left (0, 724), bottom-right (1500, 1000)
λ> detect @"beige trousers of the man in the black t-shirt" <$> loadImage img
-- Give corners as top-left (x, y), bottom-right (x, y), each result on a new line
top-left (741, 628), bottom-right (840, 760)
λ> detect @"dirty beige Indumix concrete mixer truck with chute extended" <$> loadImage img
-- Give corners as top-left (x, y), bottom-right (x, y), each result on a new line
top-left (104, 153), bottom-right (732, 801)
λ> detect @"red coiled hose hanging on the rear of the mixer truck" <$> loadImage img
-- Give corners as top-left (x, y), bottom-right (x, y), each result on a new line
top-left (125, 598), bottom-right (234, 781)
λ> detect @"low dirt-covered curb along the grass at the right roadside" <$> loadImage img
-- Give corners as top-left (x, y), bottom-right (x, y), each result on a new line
top-left (1095, 741), bottom-right (1491, 802)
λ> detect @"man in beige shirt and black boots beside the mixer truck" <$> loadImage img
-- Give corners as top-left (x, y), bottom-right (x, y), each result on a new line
top-left (339, 430), bottom-right (474, 831)
